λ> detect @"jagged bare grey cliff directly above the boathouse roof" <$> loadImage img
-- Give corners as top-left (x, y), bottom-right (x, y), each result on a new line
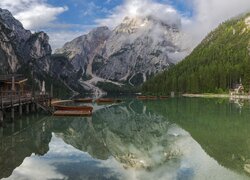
top-left (0, 9), bottom-right (52, 73)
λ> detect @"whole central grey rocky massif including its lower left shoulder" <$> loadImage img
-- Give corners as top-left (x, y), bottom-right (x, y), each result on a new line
top-left (56, 17), bottom-right (184, 85)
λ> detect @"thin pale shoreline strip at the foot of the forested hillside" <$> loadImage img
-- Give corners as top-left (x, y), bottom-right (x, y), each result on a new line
top-left (182, 94), bottom-right (250, 100)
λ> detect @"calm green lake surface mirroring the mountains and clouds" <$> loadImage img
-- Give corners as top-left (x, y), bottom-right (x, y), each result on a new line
top-left (0, 98), bottom-right (250, 180)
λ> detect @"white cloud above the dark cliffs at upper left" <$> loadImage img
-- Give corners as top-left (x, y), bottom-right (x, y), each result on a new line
top-left (0, 0), bottom-right (76, 49)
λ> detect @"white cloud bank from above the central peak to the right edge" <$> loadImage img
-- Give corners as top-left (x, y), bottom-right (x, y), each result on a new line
top-left (96, 0), bottom-right (250, 47)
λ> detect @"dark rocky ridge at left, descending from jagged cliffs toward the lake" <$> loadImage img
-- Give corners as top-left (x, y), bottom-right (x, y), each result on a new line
top-left (0, 9), bottom-right (83, 92)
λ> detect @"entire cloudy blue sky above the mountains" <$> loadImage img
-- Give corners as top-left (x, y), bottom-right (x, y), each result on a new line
top-left (0, 0), bottom-right (250, 49)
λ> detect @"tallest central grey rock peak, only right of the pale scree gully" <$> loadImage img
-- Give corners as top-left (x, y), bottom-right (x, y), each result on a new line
top-left (94, 18), bottom-right (185, 84)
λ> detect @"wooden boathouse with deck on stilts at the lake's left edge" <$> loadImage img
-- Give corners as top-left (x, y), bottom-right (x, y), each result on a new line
top-left (0, 74), bottom-right (52, 124)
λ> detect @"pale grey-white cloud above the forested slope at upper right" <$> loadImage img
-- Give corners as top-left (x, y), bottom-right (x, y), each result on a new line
top-left (187, 0), bottom-right (250, 45)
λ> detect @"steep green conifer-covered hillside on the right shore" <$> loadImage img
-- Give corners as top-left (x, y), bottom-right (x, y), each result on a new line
top-left (142, 13), bottom-right (250, 94)
